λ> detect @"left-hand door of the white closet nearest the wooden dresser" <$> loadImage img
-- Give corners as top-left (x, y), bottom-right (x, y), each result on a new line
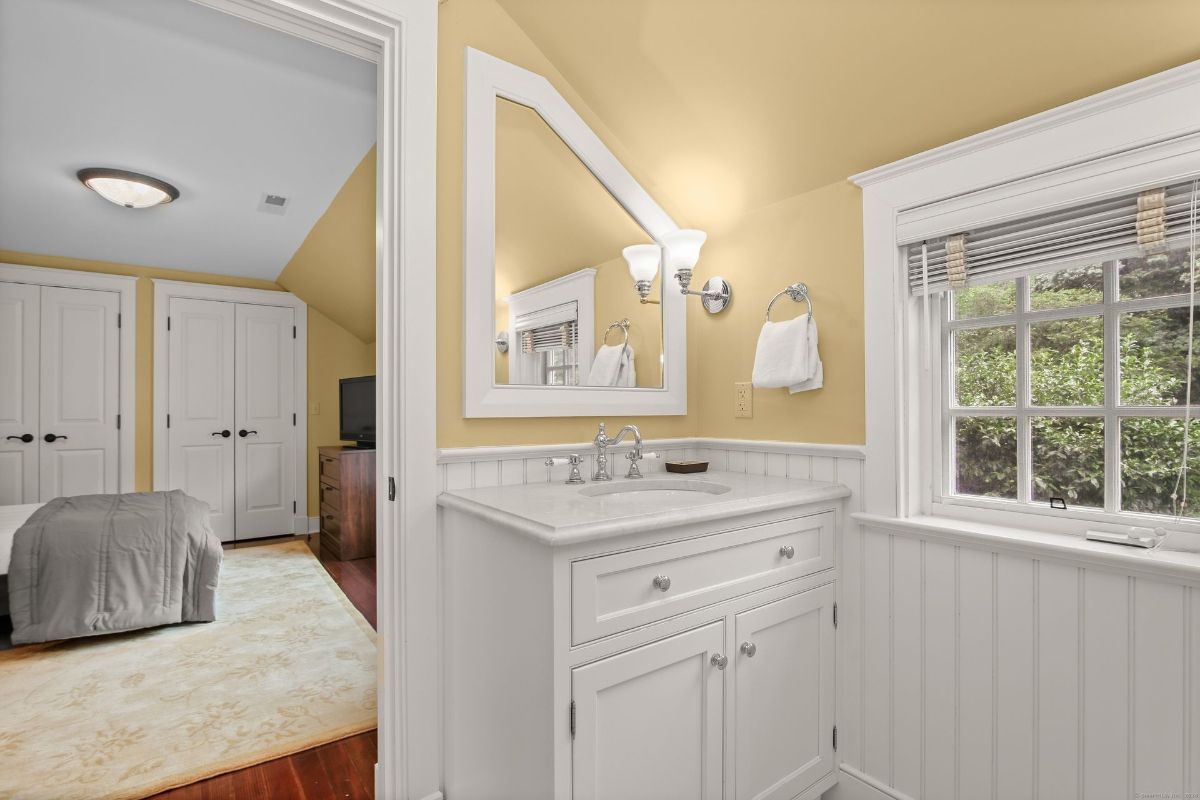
top-left (167, 297), bottom-right (236, 542)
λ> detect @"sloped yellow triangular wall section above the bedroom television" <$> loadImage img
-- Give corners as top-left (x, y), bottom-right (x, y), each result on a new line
top-left (277, 145), bottom-right (376, 342)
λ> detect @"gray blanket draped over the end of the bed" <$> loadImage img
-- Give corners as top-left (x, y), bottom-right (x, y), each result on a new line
top-left (8, 491), bottom-right (221, 644)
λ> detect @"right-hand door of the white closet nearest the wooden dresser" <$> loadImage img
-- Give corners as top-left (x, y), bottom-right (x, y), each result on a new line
top-left (234, 303), bottom-right (296, 540)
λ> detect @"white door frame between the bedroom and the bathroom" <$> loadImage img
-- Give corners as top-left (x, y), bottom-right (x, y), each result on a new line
top-left (180, 0), bottom-right (442, 800)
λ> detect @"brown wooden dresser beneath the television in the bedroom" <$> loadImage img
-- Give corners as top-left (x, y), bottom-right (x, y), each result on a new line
top-left (317, 446), bottom-right (376, 561)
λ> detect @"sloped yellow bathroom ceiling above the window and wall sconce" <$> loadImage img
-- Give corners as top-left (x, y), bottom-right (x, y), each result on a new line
top-left (494, 0), bottom-right (1200, 230)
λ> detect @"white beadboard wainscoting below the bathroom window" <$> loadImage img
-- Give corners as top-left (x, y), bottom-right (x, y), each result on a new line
top-left (836, 517), bottom-right (1200, 800)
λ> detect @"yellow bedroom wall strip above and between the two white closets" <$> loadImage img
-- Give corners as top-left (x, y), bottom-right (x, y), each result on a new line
top-left (0, 251), bottom-right (278, 492)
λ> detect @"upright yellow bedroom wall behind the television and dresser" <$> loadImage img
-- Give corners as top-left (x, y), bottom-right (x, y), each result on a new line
top-left (308, 305), bottom-right (376, 517)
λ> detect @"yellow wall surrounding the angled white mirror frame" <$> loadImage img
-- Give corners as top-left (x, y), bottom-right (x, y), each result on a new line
top-left (437, 0), bottom-right (696, 447)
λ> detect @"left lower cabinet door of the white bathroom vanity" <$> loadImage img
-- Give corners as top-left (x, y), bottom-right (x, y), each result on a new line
top-left (571, 622), bottom-right (725, 800)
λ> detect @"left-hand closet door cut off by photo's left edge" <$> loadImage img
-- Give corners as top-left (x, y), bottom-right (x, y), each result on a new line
top-left (0, 283), bottom-right (42, 505)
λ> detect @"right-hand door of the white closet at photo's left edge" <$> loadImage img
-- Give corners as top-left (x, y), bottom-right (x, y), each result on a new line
top-left (38, 287), bottom-right (120, 501)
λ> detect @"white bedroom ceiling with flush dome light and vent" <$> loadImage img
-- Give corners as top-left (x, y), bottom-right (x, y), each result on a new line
top-left (0, 0), bottom-right (376, 281)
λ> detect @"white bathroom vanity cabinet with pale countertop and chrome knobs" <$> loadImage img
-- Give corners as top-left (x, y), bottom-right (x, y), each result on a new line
top-left (440, 474), bottom-right (846, 800)
